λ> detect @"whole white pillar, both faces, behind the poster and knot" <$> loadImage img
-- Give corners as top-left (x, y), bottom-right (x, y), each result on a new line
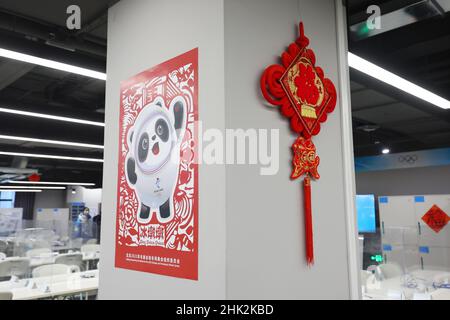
top-left (99, 0), bottom-right (358, 299)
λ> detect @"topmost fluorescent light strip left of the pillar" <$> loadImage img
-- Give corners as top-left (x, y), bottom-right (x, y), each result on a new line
top-left (0, 48), bottom-right (106, 80)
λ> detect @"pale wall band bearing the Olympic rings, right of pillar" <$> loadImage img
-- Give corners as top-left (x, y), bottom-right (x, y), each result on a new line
top-left (356, 166), bottom-right (450, 196)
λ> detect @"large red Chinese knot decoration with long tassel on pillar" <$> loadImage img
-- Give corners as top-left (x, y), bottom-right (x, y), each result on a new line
top-left (261, 22), bottom-right (337, 265)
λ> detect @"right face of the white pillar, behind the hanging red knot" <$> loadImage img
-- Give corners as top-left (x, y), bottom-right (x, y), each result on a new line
top-left (225, 0), bottom-right (356, 299)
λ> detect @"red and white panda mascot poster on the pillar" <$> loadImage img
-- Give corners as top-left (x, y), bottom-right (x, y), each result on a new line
top-left (115, 49), bottom-right (198, 280)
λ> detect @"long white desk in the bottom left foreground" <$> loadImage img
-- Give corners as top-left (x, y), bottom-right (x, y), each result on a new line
top-left (0, 270), bottom-right (98, 300)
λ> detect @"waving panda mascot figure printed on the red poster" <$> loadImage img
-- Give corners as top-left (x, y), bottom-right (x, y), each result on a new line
top-left (125, 96), bottom-right (187, 224)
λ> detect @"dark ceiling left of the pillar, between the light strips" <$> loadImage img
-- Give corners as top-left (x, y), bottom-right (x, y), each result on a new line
top-left (0, 0), bottom-right (117, 186)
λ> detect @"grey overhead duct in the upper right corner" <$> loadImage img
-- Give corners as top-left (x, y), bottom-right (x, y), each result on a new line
top-left (350, 0), bottom-right (450, 41)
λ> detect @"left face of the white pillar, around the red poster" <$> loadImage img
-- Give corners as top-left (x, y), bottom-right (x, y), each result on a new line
top-left (99, 0), bottom-right (225, 299)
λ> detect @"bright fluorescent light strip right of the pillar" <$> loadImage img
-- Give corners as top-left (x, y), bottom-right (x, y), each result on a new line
top-left (348, 52), bottom-right (450, 109)
